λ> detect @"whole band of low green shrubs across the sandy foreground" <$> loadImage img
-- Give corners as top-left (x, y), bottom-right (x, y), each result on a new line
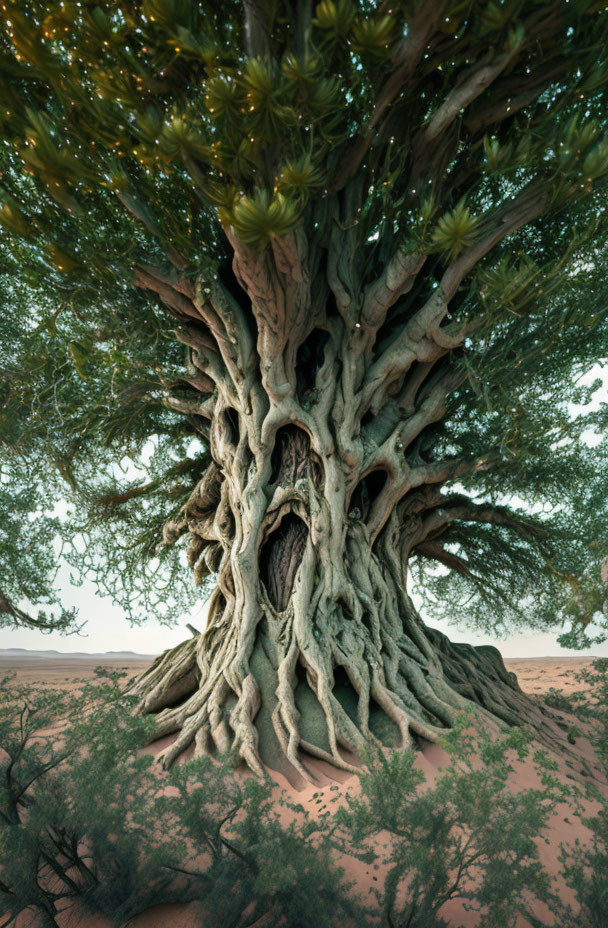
top-left (0, 661), bottom-right (608, 928)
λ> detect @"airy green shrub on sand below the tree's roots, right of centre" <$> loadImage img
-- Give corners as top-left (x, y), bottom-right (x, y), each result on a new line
top-left (337, 718), bottom-right (564, 928)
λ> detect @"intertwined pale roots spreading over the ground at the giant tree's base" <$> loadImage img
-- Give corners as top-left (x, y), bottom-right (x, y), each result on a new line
top-left (131, 588), bottom-right (576, 780)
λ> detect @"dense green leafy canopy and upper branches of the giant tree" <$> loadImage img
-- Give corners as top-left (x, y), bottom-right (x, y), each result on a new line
top-left (0, 0), bottom-right (608, 643)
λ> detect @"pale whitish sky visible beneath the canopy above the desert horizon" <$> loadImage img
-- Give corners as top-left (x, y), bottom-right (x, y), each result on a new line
top-left (0, 366), bottom-right (608, 657)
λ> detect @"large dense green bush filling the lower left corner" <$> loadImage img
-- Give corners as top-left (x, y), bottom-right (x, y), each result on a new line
top-left (0, 675), bottom-right (183, 926)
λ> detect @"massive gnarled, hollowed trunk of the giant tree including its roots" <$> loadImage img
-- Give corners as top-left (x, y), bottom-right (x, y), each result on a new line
top-left (128, 221), bottom-right (560, 777)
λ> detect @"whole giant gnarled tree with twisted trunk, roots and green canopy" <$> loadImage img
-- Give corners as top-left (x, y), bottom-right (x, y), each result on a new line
top-left (0, 0), bottom-right (608, 776)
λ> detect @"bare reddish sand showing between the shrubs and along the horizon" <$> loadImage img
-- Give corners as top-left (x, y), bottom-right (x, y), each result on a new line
top-left (0, 657), bottom-right (598, 928)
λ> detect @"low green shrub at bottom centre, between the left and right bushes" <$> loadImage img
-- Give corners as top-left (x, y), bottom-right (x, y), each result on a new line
top-left (161, 758), bottom-right (364, 928)
